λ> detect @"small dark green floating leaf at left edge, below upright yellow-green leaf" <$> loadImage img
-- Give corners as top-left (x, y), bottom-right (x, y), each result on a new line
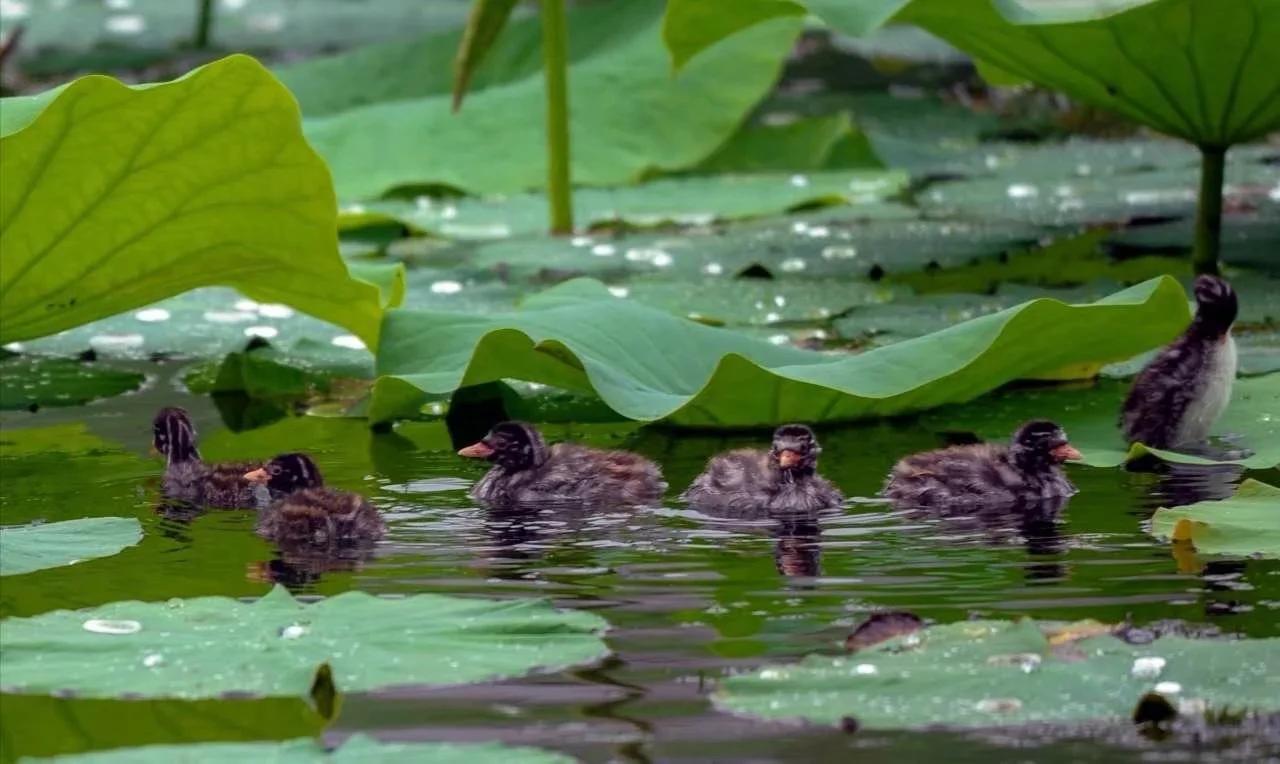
top-left (0, 356), bottom-right (146, 411)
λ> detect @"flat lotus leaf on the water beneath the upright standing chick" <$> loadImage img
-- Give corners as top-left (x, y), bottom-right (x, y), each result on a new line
top-left (925, 374), bottom-right (1280, 470)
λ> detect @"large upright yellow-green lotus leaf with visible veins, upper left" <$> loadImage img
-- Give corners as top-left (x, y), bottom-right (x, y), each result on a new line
top-left (0, 55), bottom-right (383, 347)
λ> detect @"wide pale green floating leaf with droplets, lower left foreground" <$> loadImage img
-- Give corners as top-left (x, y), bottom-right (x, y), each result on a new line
top-left (0, 586), bottom-right (608, 699)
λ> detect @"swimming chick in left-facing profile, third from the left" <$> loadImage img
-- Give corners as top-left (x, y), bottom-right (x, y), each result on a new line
top-left (458, 422), bottom-right (667, 505)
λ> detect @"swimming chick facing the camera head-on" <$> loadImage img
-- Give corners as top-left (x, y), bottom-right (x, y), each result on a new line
top-left (681, 425), bottom-right (845, 511)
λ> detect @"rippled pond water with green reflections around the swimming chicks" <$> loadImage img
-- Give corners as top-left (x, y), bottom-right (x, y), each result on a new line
top-left (0, 366), bottom-right (1280, 761)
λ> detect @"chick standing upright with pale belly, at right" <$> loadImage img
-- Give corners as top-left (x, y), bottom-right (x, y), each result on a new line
top-left (1120, 275), bottom-right (1239, 448)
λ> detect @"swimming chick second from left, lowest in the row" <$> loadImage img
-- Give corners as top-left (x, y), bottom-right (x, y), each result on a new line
top-left (244, 453), bottom-right (387, 544)
